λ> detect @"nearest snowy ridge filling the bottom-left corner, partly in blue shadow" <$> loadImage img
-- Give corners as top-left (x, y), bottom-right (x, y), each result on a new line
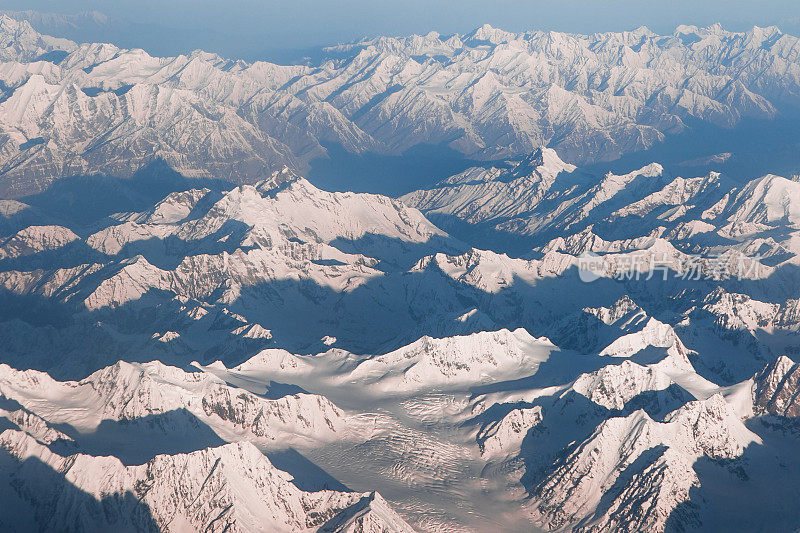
top-left (0, 430), bottom-right (411, 532)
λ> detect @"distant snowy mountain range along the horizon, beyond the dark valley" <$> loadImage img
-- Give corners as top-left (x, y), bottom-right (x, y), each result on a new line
top-left (0, 15), bottom-right (800, 196)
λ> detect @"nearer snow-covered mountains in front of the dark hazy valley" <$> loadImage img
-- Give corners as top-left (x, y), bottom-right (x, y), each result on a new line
top-left (0, 144), bottom-right (800, 531)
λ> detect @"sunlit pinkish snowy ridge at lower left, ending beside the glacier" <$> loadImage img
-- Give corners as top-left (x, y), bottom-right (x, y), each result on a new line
top-left (0, 362), bottom-right (346, 447)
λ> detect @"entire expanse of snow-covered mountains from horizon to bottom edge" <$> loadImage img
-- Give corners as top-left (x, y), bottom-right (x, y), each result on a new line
top-left (0, 13), bottom-right (800, 533)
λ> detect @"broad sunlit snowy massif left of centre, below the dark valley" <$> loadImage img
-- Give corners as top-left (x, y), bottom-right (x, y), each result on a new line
top-left (0, 169), bottom-right (448, 316)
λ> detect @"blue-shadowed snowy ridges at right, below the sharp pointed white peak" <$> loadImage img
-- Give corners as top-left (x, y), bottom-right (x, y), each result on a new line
top-left (403, 149), bottom-right (800, 275)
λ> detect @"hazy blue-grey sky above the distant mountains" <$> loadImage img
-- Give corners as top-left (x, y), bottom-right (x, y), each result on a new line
top-left (6, 0), bottom-right (800, 58)
